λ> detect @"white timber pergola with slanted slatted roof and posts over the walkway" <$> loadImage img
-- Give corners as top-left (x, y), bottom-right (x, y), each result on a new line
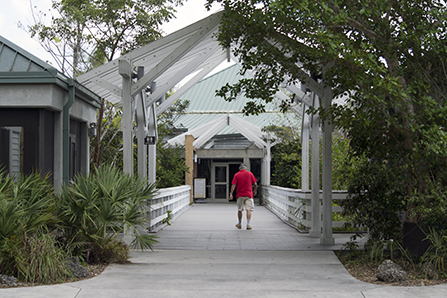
top-left (78, 12), bottom-right (334, 245)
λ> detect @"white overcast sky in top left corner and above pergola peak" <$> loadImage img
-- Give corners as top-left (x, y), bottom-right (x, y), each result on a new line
top-left (0, 0), bottom-right (219, 66)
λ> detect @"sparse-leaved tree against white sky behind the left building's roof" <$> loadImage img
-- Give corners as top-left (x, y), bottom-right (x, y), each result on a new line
top-left (28, 0), bottom-right (182, 77)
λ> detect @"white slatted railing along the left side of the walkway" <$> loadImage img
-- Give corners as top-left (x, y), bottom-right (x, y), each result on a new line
top-left (147, 185), bottom-right (191, 231)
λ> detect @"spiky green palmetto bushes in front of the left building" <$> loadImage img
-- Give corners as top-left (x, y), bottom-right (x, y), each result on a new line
top-left (0, 166), bottom-right (157, 284)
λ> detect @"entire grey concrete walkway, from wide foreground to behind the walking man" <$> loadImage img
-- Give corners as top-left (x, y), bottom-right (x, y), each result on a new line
top-left (0, 204), bottom-right (447, 298)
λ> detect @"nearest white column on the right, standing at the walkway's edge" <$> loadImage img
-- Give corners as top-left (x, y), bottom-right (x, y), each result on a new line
top-left (320, 86), bottom-right (335, 245)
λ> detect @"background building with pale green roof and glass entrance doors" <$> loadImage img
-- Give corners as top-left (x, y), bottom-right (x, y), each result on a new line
top-left (168, 64), bottom-right (299, 202)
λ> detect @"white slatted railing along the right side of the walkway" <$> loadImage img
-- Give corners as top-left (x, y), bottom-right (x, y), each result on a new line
top-left (262, 185), bottom-right (348, 231)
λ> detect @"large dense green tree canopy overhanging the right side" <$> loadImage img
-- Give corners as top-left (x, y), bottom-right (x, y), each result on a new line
top-left (208, 0), bottom-right (447, 235)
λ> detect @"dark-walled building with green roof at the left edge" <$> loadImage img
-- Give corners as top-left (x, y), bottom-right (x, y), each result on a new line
top-left (0, 36), bottom-right (101, 188)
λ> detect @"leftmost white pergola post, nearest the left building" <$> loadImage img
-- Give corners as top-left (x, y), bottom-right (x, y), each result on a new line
top-left (119, 60), bottom-right (133, 175)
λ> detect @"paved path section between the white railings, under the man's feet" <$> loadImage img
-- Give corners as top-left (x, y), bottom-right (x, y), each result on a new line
top-left (155, 203), bottom-right (362, 251)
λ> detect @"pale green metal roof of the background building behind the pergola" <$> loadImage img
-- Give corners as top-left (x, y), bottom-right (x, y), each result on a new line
top-left (175, 64), bottom-right (299, 135)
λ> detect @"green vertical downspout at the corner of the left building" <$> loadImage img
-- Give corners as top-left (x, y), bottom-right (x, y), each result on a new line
top-left (62, 79), bottom-right (75, 185)
